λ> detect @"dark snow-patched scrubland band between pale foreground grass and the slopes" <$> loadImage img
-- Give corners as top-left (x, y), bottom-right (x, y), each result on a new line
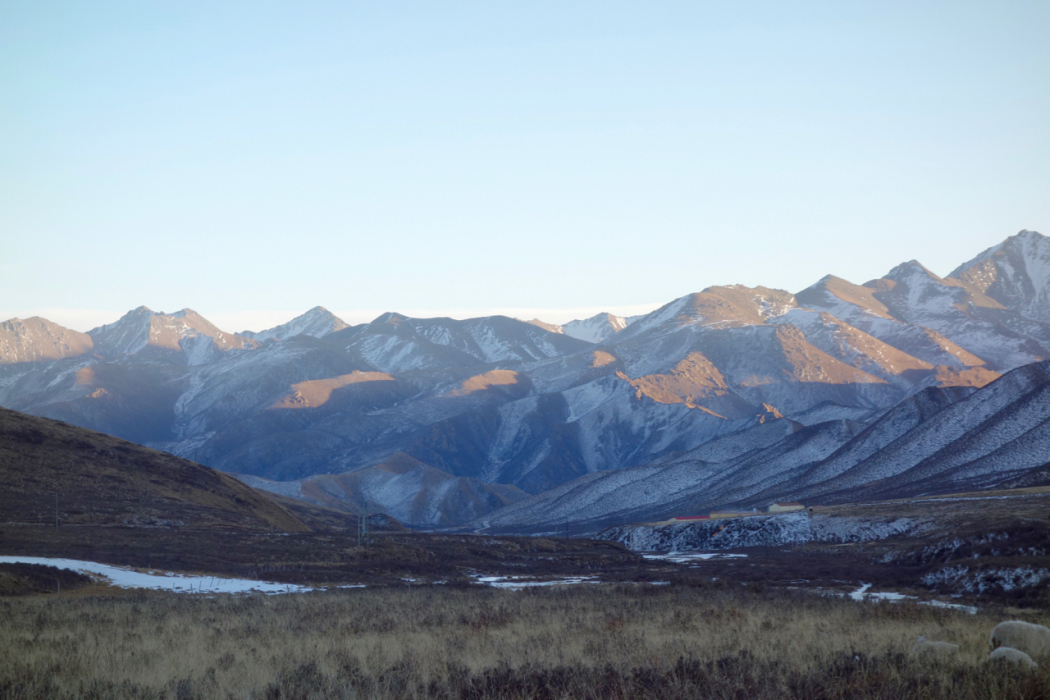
top-left (6, 488), bottom-right (1050, 609)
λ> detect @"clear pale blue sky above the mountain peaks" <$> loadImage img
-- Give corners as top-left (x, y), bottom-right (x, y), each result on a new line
top-left (0, 0), bottom-right (1050, 332)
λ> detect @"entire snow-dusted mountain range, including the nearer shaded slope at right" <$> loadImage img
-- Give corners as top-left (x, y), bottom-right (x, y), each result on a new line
top-left (0, 231), bottom-right (1050, 529)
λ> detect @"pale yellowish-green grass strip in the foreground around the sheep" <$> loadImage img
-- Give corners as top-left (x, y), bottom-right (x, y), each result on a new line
top-left (0, 585), bottom-right (1050, 700)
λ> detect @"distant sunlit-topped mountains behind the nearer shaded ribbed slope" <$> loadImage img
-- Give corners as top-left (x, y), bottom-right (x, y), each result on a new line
top-left (0, 232), bottom-right (1050, 531)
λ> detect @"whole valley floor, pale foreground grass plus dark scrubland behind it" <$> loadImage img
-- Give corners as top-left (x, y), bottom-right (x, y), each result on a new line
top-left (0, 490), bottom-right (1050, 700)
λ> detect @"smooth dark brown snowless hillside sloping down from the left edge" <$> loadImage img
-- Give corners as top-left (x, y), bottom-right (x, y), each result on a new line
top-left (0, 408), bottom-right (310, 532)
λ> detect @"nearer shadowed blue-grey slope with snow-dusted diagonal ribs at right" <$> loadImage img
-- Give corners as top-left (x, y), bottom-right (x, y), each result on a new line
top-left (475, 361), bottom-right (1050, 532)
